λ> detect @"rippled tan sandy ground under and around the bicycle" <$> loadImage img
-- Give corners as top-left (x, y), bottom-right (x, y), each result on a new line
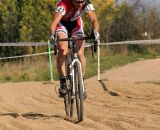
top-left (0, 58), bottom-right (160, 130)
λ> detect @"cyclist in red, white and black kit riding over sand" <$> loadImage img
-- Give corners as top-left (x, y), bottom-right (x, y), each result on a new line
top-left (50, 0), bottom-right (99, 97)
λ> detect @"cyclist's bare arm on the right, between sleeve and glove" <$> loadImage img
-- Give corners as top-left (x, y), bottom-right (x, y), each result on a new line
top-left (87, 11), bottom-right (99, 32)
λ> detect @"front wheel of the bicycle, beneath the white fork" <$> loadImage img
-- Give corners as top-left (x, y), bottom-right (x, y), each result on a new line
top-left (74, 63), bottom-right (83, 121)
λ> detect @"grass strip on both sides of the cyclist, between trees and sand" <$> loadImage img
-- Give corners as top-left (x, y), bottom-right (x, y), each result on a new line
top-left (0, 46), bottom-right (160, 82)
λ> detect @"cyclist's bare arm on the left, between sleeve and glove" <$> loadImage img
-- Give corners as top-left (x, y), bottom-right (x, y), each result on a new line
top-left (50, 12), bottom-right (63, 34)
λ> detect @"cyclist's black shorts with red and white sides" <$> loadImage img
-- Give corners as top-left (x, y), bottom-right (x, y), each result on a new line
top-left (56, 17), bottom-right (84, 36)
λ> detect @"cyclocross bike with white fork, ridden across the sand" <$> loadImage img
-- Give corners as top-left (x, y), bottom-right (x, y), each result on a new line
top-left (53, 32), bottom-right (97, 122)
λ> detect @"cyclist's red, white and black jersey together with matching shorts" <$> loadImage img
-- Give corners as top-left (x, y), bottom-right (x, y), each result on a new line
top-left (55, 0), bottom-right (94, 35)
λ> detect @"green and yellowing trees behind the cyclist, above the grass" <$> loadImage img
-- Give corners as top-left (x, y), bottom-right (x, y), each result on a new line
top-left (0, 0), bottom-right (160, 57)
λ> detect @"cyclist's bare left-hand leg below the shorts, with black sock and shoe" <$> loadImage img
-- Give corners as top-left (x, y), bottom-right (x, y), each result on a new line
top-left (57, 33), bottom-right (68, 97)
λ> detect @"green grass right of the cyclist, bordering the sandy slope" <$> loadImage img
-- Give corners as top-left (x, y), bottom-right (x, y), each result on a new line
top-left (86, 46), bottom-right (160, 78)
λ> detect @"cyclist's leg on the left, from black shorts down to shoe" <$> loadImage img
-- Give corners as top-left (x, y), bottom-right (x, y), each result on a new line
top-left (56, 21), bottom-right (77, 97)
